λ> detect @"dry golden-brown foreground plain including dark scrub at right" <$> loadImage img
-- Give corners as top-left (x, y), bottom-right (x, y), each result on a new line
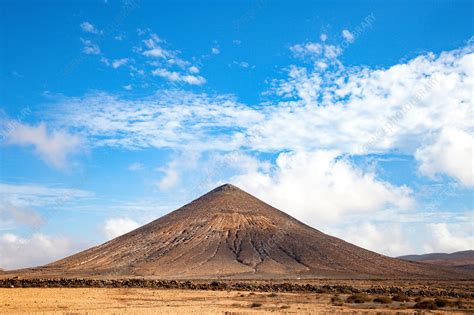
top-left (0, 280), bottom-right (474, 314)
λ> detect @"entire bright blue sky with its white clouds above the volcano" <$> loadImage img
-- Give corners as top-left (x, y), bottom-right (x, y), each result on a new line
top-left (0, 0), bottom-right (474, 268)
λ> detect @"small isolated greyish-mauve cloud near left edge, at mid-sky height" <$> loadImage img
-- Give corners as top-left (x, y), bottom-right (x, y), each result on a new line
top-left (6, 123), bottom-right (82, 169)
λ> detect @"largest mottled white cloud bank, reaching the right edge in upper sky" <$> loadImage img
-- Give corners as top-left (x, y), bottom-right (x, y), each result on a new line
top-left (256, 45), bottom-right (474, 167)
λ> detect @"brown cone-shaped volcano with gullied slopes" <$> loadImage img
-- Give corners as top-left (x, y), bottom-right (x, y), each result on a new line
top-left (37, 184), bottom-right (472, 279)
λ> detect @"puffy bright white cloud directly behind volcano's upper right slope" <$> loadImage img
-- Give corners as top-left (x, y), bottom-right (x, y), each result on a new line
top-left (232, 151), bottom-right (414, 224)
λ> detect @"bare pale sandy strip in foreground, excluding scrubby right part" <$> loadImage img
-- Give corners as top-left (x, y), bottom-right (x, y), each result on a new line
top-left (0, 288), bottom-right (472, 314)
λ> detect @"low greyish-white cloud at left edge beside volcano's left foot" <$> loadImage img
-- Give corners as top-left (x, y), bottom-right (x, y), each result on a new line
top-left (0, 233), bottom-right (83, 269)
